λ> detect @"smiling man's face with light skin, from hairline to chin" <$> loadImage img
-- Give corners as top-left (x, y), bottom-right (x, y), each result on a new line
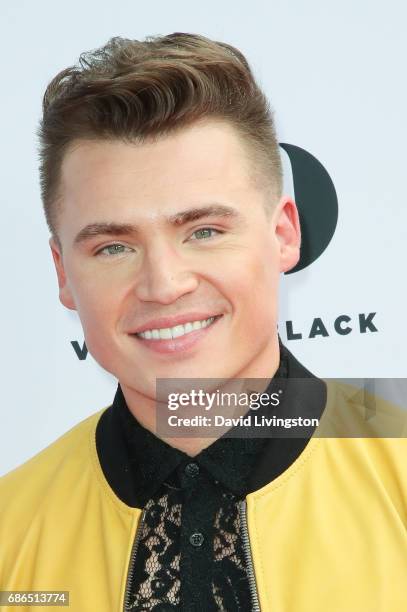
top-left (51, 122), bottom-right (300, 398)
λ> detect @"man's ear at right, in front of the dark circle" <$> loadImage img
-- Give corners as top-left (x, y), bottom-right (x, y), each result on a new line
top-left (275, 196), bottom-right (301, 272)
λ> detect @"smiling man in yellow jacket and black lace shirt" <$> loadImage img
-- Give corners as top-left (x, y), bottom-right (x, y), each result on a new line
top-left (0, 34), bottom-right (407, 612)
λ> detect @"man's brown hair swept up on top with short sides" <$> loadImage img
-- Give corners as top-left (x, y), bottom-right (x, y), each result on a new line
top-left (38, 32), bottom-right (282, 236)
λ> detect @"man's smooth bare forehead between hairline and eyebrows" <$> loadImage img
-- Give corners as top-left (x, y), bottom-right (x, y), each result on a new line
top-left (61, 122), bottom-right (255, 210)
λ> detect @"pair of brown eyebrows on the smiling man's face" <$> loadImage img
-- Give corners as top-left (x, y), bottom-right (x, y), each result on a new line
top-left (74, 204), bottom-right (241, 244)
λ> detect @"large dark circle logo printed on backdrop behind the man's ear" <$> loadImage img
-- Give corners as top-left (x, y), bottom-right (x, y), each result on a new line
top-left (280, 142), bottom-right (338, 274)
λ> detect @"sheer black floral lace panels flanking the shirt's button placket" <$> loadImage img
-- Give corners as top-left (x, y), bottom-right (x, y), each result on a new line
top-left (129, 486), bottom-right (250, 612)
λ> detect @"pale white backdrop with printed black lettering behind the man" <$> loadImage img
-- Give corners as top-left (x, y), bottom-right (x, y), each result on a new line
top-left (0, 0), bottom-right (407, 474)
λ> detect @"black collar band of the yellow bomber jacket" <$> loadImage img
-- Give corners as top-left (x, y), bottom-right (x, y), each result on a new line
top-left (96, 341), bottom-right (326, 508)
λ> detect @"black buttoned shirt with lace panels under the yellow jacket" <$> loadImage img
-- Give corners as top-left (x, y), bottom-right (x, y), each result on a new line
top-left (115, 355), bottom-right (287, 612)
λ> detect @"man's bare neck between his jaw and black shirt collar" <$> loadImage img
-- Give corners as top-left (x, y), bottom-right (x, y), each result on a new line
top-left (121, 334), bottom-right (280, 457)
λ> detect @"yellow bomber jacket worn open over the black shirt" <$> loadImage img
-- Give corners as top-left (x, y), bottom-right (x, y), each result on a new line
top-left (0, 376), bottom-right (407, 612)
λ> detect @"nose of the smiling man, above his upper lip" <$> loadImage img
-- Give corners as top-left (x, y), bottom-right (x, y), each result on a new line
top-left (136, 244), bottom-right (198, 304)
